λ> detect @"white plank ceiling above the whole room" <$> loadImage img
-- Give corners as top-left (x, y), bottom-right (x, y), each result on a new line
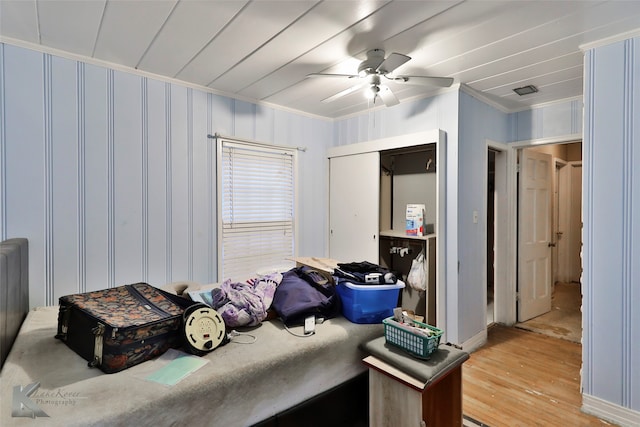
top-left (0, 0), bottom-right (640, 118)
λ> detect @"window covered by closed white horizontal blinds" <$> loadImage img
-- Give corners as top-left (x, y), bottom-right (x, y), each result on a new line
top-left (218, 138), bottom-right (297, 282)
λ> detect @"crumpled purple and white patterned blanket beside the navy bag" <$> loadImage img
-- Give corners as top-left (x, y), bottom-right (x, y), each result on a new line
top-left (211, 273), bottom-right (282, 327)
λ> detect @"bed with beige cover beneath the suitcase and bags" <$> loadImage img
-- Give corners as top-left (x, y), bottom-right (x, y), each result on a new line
top-left (0, 280), bottom-right (383, 426)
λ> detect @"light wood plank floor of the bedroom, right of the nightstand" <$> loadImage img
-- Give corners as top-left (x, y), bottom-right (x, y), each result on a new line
top-left (462, 325), bottom-right (613, 427)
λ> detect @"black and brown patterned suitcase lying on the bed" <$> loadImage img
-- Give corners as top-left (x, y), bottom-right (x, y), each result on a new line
top-left (56, 283), bottom-right (194, 374)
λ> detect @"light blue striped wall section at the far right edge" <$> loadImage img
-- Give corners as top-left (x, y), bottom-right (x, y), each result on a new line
top-left (582, 38), bottom-right (640, 419)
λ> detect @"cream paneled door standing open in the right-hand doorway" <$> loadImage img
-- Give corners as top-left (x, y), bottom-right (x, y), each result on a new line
top-left (518, 149), bottom-right (553, 322)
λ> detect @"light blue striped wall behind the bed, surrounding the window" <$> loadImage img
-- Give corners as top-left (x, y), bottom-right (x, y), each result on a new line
top-left (0, 44), bottom-right (332, 306)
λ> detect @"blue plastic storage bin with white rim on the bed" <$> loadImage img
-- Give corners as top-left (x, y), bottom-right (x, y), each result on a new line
top-left (336, 281), bottom-right (404, 323)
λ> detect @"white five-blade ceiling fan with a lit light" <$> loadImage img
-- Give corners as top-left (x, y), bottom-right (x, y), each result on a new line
top-left (307, 49), bottom-right (453, 107)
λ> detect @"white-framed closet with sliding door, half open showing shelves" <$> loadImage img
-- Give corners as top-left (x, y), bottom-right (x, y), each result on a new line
top-left (328, 131), bottom-right (445, 326)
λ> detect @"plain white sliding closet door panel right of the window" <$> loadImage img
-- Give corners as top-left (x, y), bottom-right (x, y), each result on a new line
top-left (329, 152), bottom-right (380, 264)
